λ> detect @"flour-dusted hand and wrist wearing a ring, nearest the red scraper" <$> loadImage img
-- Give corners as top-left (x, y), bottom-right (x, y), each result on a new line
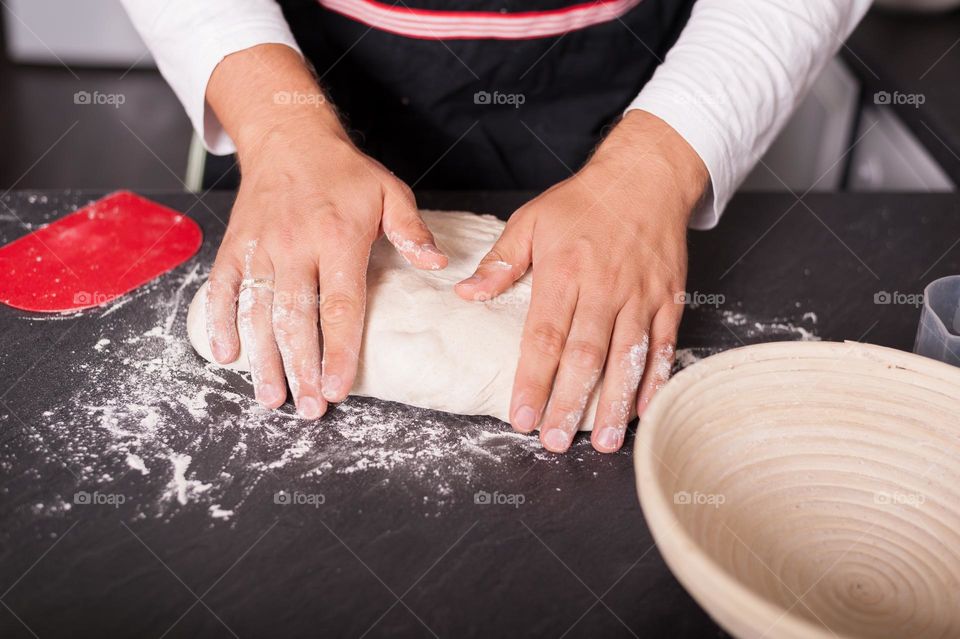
top-left (207, 45), bottom-right (447, 419)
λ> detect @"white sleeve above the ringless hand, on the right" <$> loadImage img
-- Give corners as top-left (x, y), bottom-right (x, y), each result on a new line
top-left (627, 0), bottom-right (871, 229)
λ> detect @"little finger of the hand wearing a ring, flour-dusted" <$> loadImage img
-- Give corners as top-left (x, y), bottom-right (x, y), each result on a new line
top-left (205, 254), bottom-right (242, 364)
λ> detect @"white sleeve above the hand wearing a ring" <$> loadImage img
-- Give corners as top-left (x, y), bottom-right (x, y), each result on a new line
top-left (122, 0), bottom-right (302, 155)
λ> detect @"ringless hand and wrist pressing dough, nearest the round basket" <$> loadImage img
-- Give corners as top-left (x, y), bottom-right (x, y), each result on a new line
top-left (456, 111), bottom-right (708, 452)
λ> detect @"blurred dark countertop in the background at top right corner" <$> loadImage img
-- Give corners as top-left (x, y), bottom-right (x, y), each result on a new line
top-left (841, 9), bottom-right (960, 184)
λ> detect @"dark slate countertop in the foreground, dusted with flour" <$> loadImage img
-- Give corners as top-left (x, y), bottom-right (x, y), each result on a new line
top-left (0, 192), bottom-right (960, 638)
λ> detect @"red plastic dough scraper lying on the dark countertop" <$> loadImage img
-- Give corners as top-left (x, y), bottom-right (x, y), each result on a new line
top-left (0, 191), bottom-right (203, 313)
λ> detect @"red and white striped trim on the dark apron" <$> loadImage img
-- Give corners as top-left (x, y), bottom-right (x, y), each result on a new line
top-left (317, 0), bottom-right (642, 40)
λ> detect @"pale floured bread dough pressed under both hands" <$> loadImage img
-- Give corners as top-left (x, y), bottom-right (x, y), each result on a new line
top-left (187, 211), bottom-right (600, 430)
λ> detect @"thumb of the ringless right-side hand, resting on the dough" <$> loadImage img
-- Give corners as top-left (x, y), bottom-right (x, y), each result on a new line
top-left (454, 214), bottom-right (533, 300)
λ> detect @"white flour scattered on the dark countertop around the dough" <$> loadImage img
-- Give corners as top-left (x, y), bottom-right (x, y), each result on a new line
top-left (16, 258), bottom-right (818, 522)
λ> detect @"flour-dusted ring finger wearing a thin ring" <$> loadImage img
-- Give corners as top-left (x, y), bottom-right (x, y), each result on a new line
top-left (237, 242), bottom-right (287, 408)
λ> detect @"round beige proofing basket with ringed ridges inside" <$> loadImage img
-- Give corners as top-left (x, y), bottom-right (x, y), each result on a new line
top-left (634, 342), bottom-right (960, 639)
